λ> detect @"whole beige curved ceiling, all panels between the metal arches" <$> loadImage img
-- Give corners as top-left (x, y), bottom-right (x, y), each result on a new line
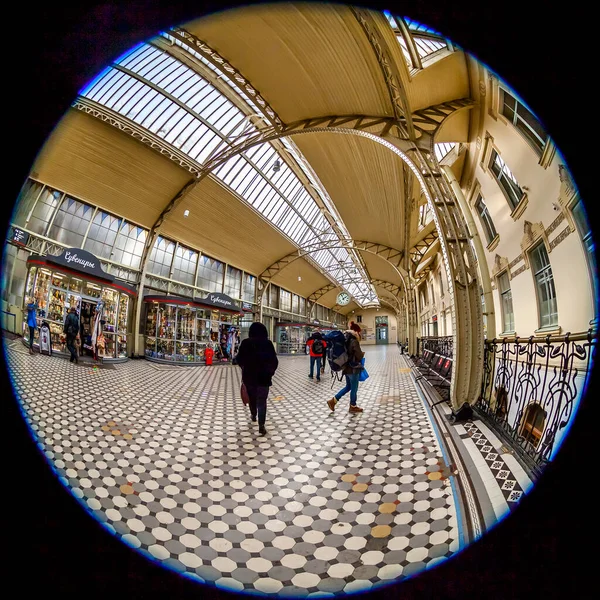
top-left (24, 3), bottom-right (478, 313)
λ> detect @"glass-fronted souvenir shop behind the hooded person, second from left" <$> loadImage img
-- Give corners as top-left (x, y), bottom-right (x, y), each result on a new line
top-left (144, 293), bottom-right (243, 365)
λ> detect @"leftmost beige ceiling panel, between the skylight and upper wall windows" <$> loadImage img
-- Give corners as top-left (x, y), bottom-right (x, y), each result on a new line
top-left (32, 109), bottom-right (192, 227)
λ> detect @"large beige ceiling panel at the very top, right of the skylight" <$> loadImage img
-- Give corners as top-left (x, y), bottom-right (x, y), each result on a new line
top-left (185, 3), bottom-right (393, 123)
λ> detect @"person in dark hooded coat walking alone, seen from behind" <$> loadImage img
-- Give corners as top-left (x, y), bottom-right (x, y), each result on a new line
top-left (236, 322), bottom-right (279, 435)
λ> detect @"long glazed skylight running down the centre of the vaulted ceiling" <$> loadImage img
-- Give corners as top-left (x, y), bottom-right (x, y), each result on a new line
top-left (81, 34), bottom-right (378, 306)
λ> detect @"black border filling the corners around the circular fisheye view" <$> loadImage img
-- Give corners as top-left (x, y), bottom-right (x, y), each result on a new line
top-left (2, 0), bottom-right (598, 599)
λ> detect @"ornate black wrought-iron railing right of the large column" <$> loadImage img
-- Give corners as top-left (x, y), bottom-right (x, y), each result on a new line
top-left (473, 329), bottom-right (598, 475)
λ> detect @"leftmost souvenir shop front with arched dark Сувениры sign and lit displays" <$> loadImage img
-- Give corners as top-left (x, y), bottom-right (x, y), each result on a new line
top-left (23, 248), bottom-right (136, 362)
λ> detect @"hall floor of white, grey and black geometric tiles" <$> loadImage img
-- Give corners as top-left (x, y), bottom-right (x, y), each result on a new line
top-left (5, 340), bottom-right (524, 596)
